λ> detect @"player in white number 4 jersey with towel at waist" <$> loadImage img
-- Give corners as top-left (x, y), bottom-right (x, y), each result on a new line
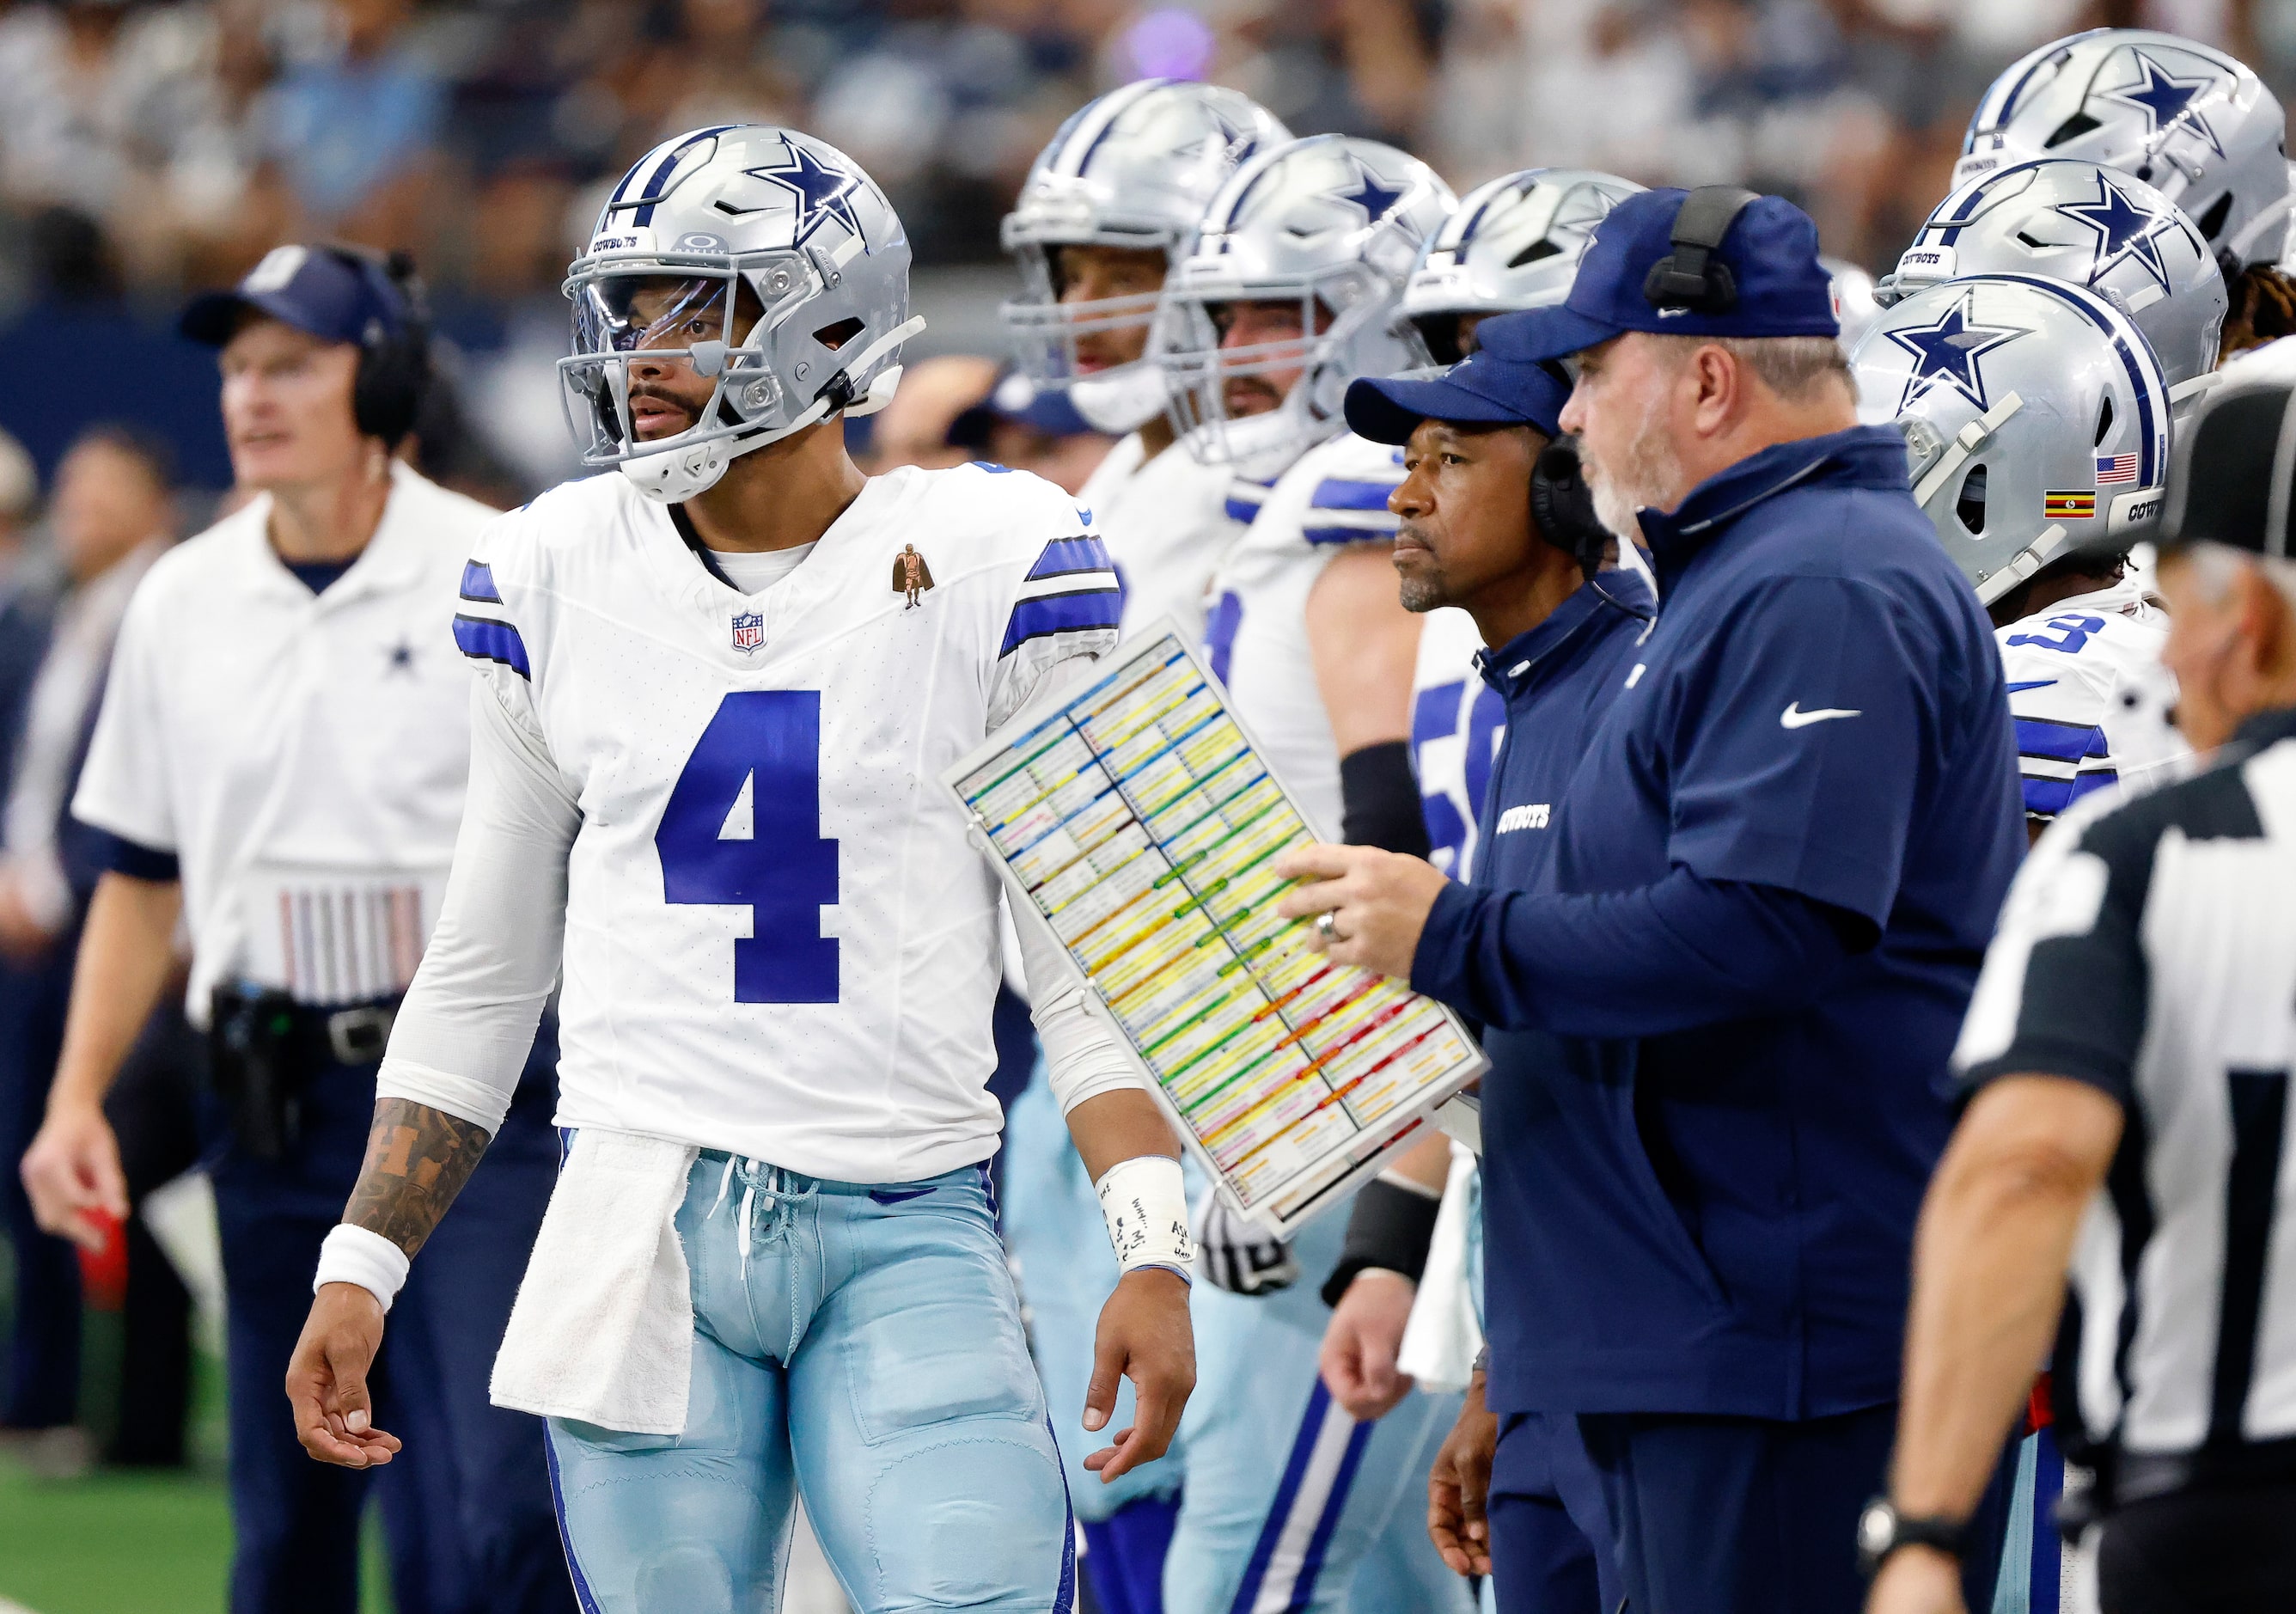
top-left (275, 126), bottom-right (1192, 1614)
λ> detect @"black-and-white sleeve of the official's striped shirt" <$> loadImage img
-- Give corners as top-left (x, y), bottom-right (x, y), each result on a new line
top-left (1954, 799), bottom-right (2163, 1104)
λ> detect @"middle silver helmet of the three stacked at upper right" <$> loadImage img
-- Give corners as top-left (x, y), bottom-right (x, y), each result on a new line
top-left (1880, 158), bottom-right (2225, 388)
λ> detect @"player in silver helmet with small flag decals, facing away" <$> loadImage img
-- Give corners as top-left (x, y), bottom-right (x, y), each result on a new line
top-left (1853, 276), bottom-right (2186, 859)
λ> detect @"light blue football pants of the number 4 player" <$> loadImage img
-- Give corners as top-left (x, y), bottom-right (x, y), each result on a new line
top-left (549, 1155), bottom-right (1077, 1614)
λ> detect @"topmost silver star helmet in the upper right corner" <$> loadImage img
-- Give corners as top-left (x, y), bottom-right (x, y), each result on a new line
top-left (1954, 28), bottom-right (2289, 276)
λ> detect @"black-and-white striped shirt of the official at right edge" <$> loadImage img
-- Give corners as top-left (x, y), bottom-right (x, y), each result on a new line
top-left (1954, 712), bottom-right (2296, 1499)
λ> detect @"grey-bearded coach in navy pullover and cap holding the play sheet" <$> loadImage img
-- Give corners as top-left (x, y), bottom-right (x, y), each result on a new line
top-left (1279, 188), bottom-right (2023, 1614)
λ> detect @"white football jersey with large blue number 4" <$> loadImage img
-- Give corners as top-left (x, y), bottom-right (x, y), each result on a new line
top-left (431, 466), bottom-right (1121, 1183)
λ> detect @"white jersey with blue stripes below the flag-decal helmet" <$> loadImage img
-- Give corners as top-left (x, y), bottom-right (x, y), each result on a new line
top-left (1995, 574), bottom-right (2193, 817)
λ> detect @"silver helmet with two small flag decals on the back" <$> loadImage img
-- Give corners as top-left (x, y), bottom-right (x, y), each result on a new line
top-left (1851, 276), bottom-right (2170, 604)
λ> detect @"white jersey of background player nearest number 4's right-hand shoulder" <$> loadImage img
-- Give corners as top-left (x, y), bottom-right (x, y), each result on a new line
top-left (1077, 431), bottom-right (1244, 643)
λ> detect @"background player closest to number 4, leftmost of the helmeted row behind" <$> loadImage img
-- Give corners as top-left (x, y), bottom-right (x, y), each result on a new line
top-left (1004, 80), bottom-right (1291, 1614)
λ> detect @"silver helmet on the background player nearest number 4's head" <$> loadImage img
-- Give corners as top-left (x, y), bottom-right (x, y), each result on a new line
top-left (1001, 78), bottom-right (1291, 431)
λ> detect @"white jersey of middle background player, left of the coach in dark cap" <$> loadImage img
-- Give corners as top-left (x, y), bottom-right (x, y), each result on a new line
top-left (1203, 431), bottom-right (1403, 841)
